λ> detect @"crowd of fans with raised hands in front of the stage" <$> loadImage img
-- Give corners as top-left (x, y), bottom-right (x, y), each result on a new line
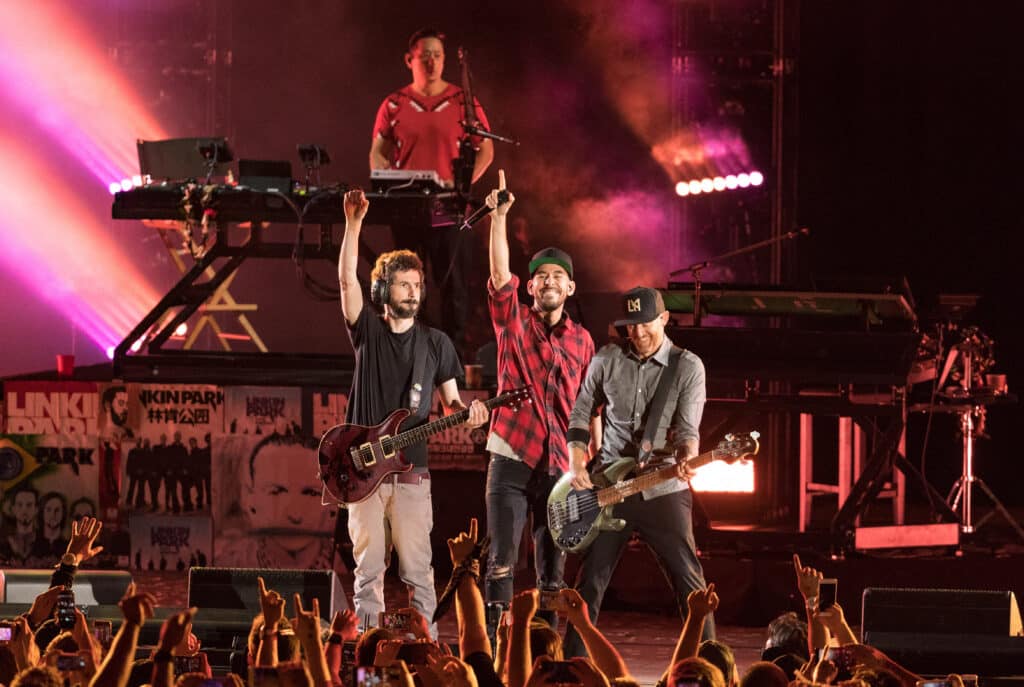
top-left (0, 517), bottom-right (978, 687)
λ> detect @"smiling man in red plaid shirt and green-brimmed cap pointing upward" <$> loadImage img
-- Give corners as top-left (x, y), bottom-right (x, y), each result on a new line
top-left (484, 170), bottom-right (594, 634)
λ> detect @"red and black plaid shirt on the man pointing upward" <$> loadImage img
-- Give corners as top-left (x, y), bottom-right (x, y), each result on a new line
top-left (487, 274), bottom-right (594, 474)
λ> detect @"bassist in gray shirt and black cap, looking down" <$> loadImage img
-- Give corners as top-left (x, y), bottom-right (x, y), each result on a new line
top-left (564, 287), bottom-right (715, 656)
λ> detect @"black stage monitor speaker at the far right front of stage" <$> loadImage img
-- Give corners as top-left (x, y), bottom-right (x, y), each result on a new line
top-left (861, 588), bottom-right (1024, 677)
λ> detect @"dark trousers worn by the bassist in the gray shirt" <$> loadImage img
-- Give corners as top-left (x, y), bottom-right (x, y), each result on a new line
top-left (562, 489), bottom-right (715, 657)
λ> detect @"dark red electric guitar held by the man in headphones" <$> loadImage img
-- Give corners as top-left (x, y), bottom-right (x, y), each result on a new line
top-left (318, 389), bottom-right (529, 504)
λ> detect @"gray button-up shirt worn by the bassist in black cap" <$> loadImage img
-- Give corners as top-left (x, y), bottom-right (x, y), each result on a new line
top-left (569, 337), bottom-right (707, 499)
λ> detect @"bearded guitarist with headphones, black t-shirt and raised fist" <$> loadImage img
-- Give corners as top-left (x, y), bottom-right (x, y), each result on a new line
top-left (338, 186), bottom-right (489, 635)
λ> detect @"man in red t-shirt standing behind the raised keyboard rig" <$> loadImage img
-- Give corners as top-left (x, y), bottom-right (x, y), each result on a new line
top-left (370, 29), bottom-right (495, 354)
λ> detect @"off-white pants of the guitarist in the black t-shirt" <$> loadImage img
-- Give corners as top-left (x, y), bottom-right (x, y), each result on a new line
top-left (348, 476), bottom-right (437, 638)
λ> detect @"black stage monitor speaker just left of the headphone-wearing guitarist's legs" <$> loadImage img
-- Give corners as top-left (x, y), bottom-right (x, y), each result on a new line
top-left (188, 567), bottom-right (348, 621)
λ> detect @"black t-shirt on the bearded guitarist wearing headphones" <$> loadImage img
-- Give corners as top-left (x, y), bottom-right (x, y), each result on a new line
top-left (345, 305), bottom-right (462, 468)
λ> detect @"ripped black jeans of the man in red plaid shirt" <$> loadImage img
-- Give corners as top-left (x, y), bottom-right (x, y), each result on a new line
top-left (483, 455), bottom-right (565, 603)
